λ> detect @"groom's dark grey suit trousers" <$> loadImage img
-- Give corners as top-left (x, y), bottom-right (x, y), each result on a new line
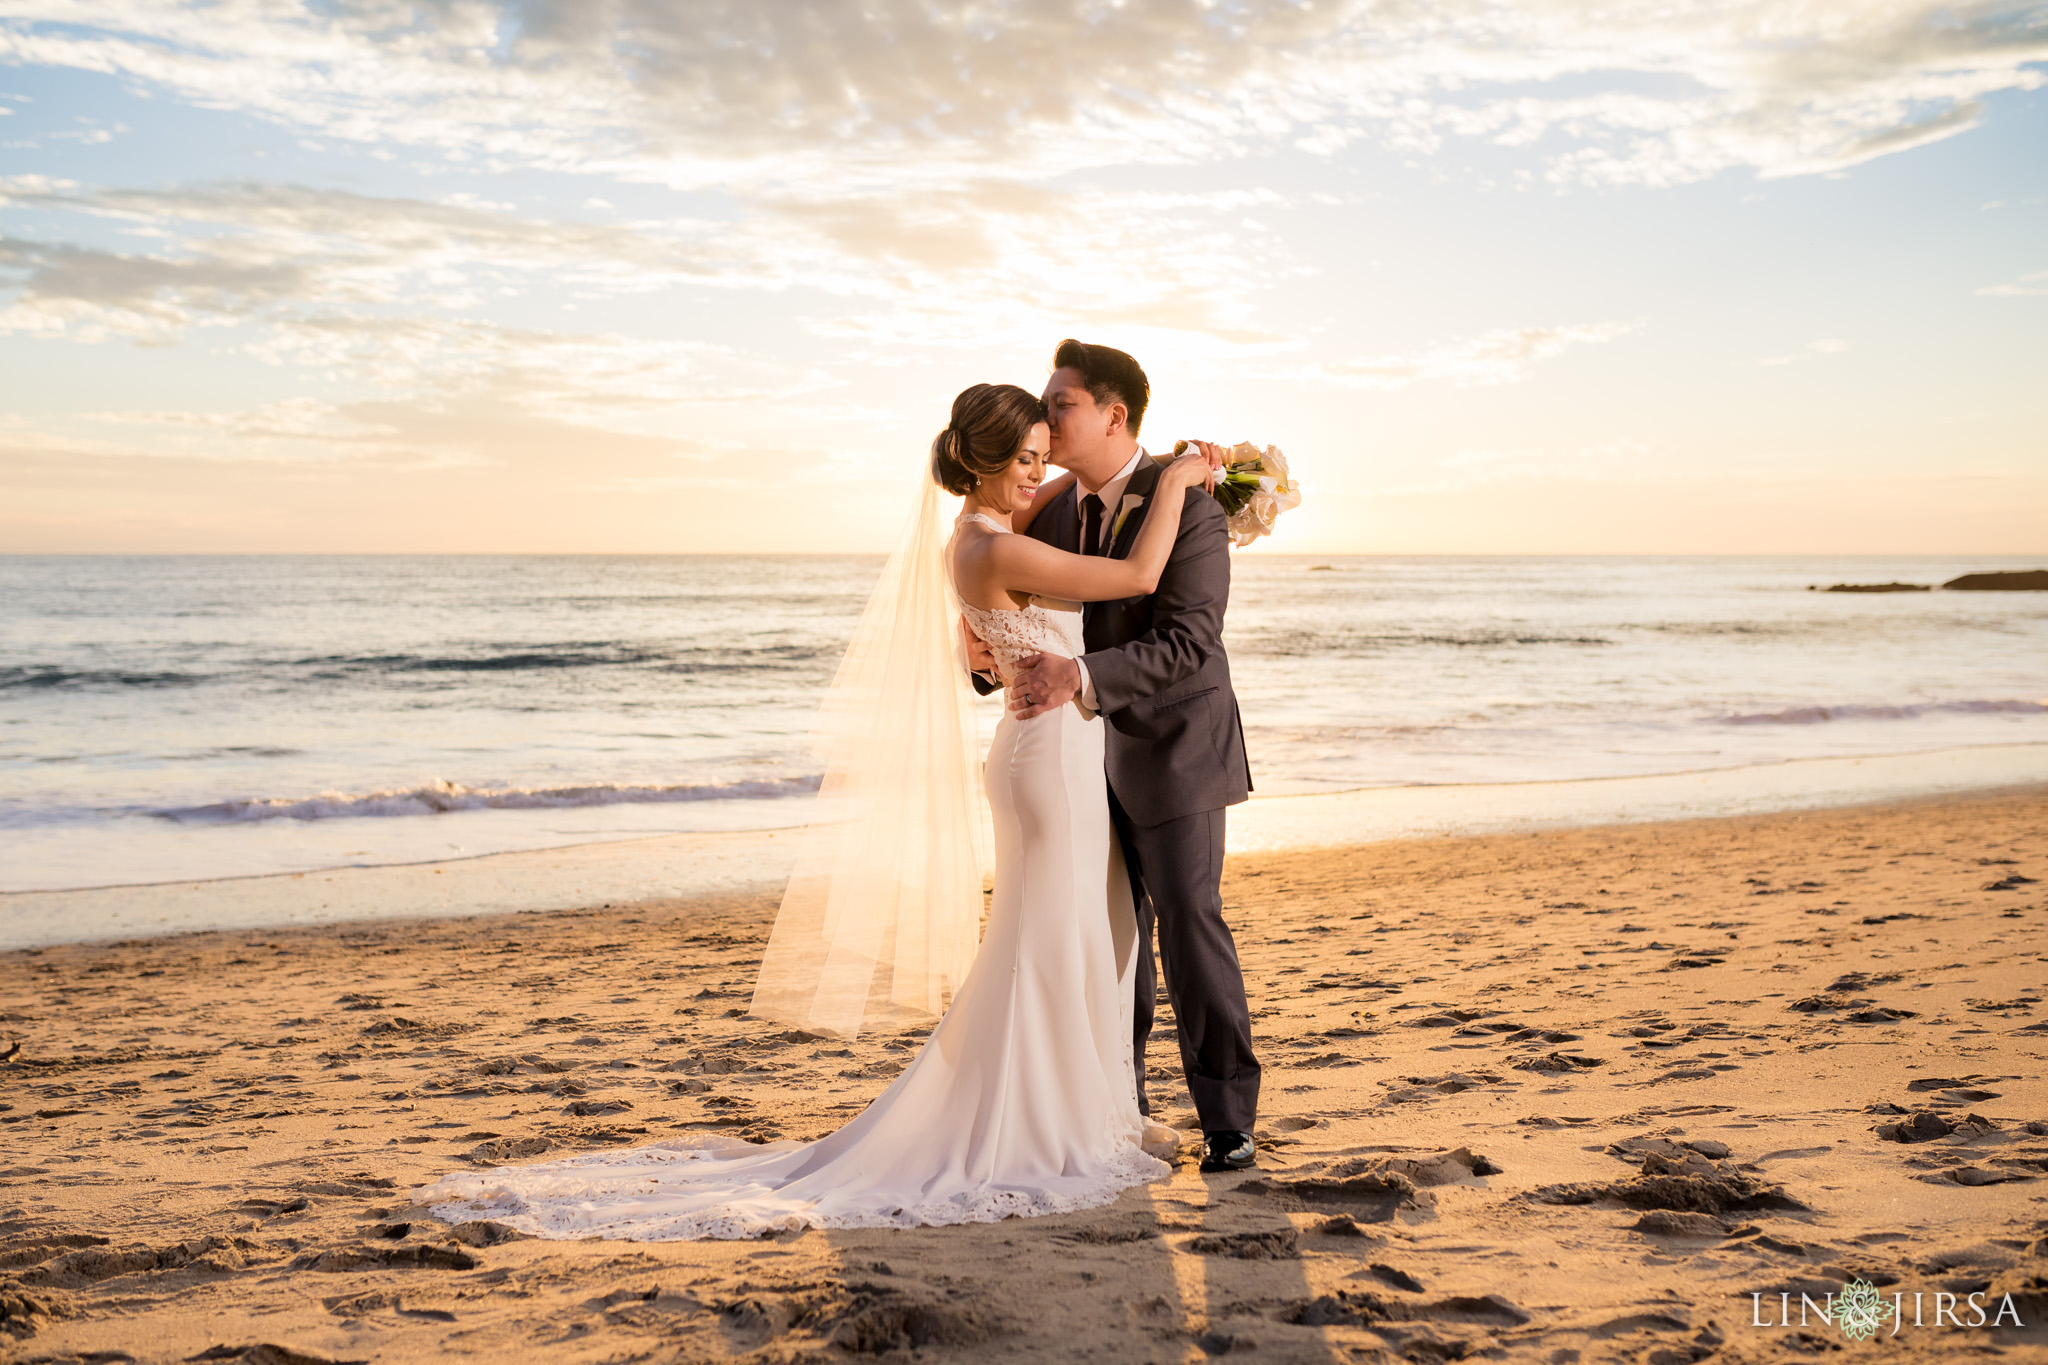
top-left (1110, 792), bottom-right (1260, 1132)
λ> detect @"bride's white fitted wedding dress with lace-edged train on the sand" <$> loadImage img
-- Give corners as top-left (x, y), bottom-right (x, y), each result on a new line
top-left (416, 518), bottom-right (1169, 1242)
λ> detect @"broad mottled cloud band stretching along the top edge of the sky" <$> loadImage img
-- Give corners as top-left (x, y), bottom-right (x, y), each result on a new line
top-left (0, 0), bottom-right (2048, 196)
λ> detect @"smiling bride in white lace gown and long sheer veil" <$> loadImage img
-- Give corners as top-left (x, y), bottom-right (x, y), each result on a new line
top-left (416, 385), bottom-right (1210, 1240)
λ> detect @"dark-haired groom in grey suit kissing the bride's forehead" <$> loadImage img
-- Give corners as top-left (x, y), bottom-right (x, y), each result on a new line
top-left (973, 340), bottom-right (1260, 1171)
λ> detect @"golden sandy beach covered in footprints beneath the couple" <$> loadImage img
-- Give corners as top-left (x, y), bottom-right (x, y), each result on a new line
top-left (0, 788), bottom-right (2048, 1365)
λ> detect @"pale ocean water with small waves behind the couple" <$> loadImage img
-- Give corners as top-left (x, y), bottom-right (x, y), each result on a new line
top-left (0, 553), bottom-right (2048, 890)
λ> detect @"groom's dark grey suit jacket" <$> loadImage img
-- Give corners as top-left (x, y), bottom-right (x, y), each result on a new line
top-left (1028, 458), bottom-right (1251, 827)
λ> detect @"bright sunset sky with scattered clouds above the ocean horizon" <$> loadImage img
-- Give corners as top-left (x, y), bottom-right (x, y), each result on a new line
top-left (0, 0), bottom-right (2048, 567)
